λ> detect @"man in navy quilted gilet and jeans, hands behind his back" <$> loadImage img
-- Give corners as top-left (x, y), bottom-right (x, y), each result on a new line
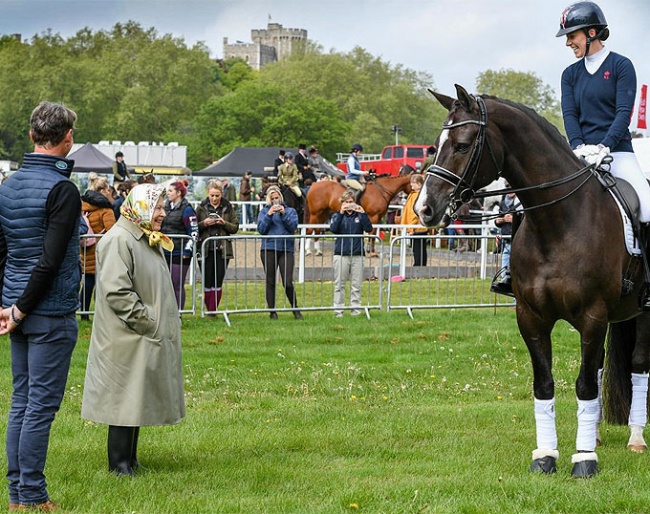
top-left (0, 102), bottom-right (81, 512)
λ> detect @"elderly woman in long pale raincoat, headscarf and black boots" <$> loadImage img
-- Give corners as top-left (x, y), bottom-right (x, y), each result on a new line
top-left (81, 184), bottom-right (185, 476)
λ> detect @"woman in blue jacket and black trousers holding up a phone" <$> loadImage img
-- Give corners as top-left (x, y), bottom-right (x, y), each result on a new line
top-left (257, 186), bottom-right (302, 319)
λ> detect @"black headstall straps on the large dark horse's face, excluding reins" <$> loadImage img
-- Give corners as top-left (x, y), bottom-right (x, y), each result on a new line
top-left (425, 96), bottom-right (489, 216)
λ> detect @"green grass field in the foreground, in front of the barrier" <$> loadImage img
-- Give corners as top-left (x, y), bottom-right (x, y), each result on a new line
top-left (0, 309), bottom-right (650, 514)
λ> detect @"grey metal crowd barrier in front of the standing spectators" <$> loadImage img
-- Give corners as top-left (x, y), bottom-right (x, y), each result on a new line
top-left (79, 221), bottom-right (513, 325)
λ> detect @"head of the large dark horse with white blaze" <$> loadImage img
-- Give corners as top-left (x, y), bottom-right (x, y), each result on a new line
top-left (415, 85), bottom-right (497, 227)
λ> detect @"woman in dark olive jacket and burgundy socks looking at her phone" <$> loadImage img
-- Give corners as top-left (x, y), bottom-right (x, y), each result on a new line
top-left (196, 180), bottom-right (239, 315)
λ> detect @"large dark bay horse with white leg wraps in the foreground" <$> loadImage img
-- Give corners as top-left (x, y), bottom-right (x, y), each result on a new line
top-left (415, 85), bottom-right (650, 478)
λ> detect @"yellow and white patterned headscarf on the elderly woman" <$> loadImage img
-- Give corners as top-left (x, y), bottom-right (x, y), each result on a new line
top-left (120, 184), bottom-right (174, 252)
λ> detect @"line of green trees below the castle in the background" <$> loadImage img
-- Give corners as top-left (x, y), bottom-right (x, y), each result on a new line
top-left (0, 21), bottom-right (561, 170)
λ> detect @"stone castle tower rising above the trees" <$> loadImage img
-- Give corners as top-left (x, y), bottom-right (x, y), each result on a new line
top-left (223, 22), bottom-right (307, 70)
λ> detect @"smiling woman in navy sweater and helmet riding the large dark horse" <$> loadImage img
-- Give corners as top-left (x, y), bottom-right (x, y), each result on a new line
top-left (556, 2), bottom-right (650, 309)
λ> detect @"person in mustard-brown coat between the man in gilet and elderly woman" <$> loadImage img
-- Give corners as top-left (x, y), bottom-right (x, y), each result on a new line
top-left (80, 173), bottom-right (117, 320)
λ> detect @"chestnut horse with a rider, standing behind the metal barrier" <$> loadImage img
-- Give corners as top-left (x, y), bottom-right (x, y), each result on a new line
top-left (303, 175), bottom-right (411, 256)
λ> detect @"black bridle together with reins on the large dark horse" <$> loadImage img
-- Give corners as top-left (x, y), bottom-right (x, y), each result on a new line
top-left (425, 95), bottom-right (596, 219)
